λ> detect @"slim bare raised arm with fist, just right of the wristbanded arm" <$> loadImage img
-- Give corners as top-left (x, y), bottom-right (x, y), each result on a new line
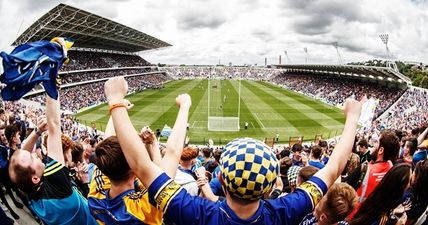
top-left (161, 94), bottom-right (192, 178)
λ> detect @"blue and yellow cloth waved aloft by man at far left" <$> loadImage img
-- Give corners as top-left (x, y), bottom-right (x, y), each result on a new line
top-left (0, 38), bottom-right (73, 101)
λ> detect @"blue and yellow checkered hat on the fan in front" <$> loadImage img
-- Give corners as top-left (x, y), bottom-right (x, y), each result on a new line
top-left (220, 138), bottom-right (279, 200)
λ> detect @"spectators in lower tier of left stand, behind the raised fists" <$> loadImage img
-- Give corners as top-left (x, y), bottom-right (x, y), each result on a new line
top-left (28, 73), bottom-right (170, 112)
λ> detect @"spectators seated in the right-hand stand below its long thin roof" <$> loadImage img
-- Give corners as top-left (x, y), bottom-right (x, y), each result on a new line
top-left (272, 74), bottom-right (405, 118)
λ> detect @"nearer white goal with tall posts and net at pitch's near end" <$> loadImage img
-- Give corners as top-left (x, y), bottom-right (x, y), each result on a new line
top-left (208, 79), bottom-right (241, 131)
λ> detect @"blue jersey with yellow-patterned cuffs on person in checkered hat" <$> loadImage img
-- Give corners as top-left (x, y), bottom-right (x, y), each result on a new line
top-left (149, 173), bottom-right (327, 225)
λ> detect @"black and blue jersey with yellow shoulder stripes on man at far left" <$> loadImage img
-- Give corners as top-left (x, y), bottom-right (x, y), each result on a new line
top-left (29, 158), bottom-right (96, 225)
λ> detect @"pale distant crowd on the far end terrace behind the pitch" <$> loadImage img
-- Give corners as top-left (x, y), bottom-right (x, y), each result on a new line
top-left (161, 66), bottom-right (280, 80)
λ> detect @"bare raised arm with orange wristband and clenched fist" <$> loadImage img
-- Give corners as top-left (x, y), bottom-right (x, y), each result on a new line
top-left (104, 76), bottom-right (162, 187)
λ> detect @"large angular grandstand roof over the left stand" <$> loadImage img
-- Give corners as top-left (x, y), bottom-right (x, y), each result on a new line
top-left (12, 3), bottom-right (171, 52)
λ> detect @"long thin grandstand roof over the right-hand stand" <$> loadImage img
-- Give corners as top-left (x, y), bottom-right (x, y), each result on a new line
top-left (275, 64), bottom-right (411, 84)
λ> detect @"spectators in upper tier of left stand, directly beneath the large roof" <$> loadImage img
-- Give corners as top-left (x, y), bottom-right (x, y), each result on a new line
top-left (61, 51), bottom-right (151, 71)
